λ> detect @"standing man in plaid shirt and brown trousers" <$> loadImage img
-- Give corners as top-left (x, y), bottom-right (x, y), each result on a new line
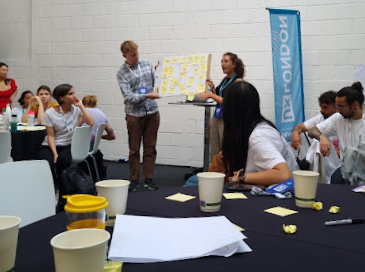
top-left (117, 41), bottom-right (160, 192)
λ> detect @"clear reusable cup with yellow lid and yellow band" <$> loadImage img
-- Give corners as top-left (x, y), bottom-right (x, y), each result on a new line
top-left (65, 195), bottom-right (108, 230)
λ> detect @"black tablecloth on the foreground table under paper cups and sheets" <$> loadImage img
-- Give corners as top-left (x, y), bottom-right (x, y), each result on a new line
top-left (16, 185), bottom-right (365, 272)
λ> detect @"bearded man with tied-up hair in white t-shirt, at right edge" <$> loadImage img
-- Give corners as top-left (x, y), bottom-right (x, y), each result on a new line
top-left (309, 82), bottom-right (365, 183)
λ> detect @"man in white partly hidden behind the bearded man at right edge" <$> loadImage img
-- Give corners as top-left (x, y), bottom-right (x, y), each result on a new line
top-left (291, 91), bottom-right (338, 151)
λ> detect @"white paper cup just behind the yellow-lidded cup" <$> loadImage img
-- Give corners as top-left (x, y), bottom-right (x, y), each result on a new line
top-left (95, 179), bottom-right (130, 226)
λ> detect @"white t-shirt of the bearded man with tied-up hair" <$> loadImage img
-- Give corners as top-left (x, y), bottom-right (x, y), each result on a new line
top-left (317, 113), bottom-right (365, 158)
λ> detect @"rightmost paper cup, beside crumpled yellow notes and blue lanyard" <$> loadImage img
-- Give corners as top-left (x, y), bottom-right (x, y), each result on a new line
top-left (293, 170), bottom-right (319, 208)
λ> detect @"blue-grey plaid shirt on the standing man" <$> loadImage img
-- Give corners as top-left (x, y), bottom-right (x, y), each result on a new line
top-left (117, 61), bottom-right (158, 117)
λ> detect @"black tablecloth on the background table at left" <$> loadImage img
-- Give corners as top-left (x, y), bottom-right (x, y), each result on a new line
top-left (11, 129), bottom-right (47, 161)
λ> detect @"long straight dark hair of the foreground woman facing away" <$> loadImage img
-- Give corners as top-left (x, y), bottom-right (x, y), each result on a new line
top-left (222, 81), bottom-right (280, 176)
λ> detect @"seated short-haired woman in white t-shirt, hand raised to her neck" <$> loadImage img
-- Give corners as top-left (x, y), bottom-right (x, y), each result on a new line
top-left (38, 84), bottom-right (94, 183)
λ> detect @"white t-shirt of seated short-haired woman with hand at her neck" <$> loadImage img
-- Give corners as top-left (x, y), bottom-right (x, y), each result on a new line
top-left (42, 105), bottom-right (82, 146)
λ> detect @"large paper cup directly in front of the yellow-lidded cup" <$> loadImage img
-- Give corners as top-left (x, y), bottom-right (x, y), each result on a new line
top-left (51, 229), bottom-right (110, 272)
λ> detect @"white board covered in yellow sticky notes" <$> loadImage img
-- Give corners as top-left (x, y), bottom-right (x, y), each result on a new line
top-left (157, 54), bottom-right (212, 97)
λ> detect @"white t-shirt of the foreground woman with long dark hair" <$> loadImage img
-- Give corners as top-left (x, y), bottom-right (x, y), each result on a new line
top-left (246, 122), bottom-right (299, 173)
